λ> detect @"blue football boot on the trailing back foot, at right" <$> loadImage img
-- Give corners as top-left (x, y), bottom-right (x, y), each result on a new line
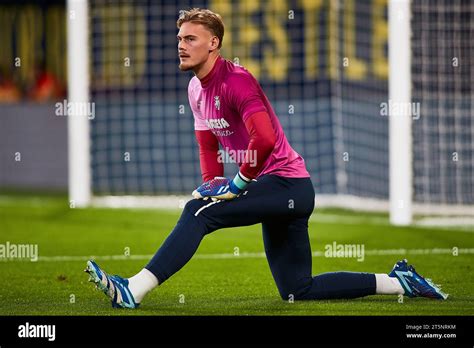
top-left (389, 259), bottom-right (448, 300)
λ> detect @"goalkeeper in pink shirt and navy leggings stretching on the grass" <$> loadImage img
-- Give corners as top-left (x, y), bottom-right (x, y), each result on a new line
top-left (86, 9), bottom-right (447, 308)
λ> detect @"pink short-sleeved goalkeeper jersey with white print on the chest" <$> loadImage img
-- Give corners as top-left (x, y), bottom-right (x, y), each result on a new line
top-left (188, 57), bottom-right (309, 178)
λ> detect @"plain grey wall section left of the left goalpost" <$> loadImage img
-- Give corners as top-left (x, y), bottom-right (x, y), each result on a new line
top-left (0, 104), bottom-right (68, 191)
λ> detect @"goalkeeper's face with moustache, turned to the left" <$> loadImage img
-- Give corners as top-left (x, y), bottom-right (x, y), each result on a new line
top-left (177, 22), bottom-right (218, 71)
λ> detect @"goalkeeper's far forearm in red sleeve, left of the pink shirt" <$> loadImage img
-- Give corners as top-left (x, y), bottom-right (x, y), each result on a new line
top-left (195, 130), bottom-right (224, 182)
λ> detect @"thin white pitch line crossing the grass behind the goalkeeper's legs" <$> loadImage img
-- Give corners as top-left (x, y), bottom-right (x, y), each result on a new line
top-left (0, 248), bottom-right (474, 262)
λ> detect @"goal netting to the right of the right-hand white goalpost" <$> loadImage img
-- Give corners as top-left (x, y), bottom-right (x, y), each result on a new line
top-left (411, 0), bottom-right (474, 214)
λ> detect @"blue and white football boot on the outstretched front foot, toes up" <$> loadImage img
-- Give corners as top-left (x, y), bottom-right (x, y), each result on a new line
top-left (84, 260), bottom-right (140, 309)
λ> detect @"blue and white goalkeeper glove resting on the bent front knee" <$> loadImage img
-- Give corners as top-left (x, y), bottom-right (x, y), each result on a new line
top-left (193, 173), bottom-right (250, 200)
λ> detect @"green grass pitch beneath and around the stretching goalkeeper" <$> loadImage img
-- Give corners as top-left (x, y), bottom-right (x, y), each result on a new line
top-left (0, 194), bottom-right (474, 315)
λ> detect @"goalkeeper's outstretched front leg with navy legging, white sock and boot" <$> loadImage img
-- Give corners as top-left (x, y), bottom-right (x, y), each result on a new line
top-left (86, 175), bottom-right (298, 308)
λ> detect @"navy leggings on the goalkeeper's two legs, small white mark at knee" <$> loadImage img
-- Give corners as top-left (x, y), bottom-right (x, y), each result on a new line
top-left (146, 175), bottom-right (375, 300)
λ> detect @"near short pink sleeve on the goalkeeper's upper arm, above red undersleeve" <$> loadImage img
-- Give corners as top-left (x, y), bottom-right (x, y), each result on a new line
top-left (226, 71), bottom-right (268, 122)
